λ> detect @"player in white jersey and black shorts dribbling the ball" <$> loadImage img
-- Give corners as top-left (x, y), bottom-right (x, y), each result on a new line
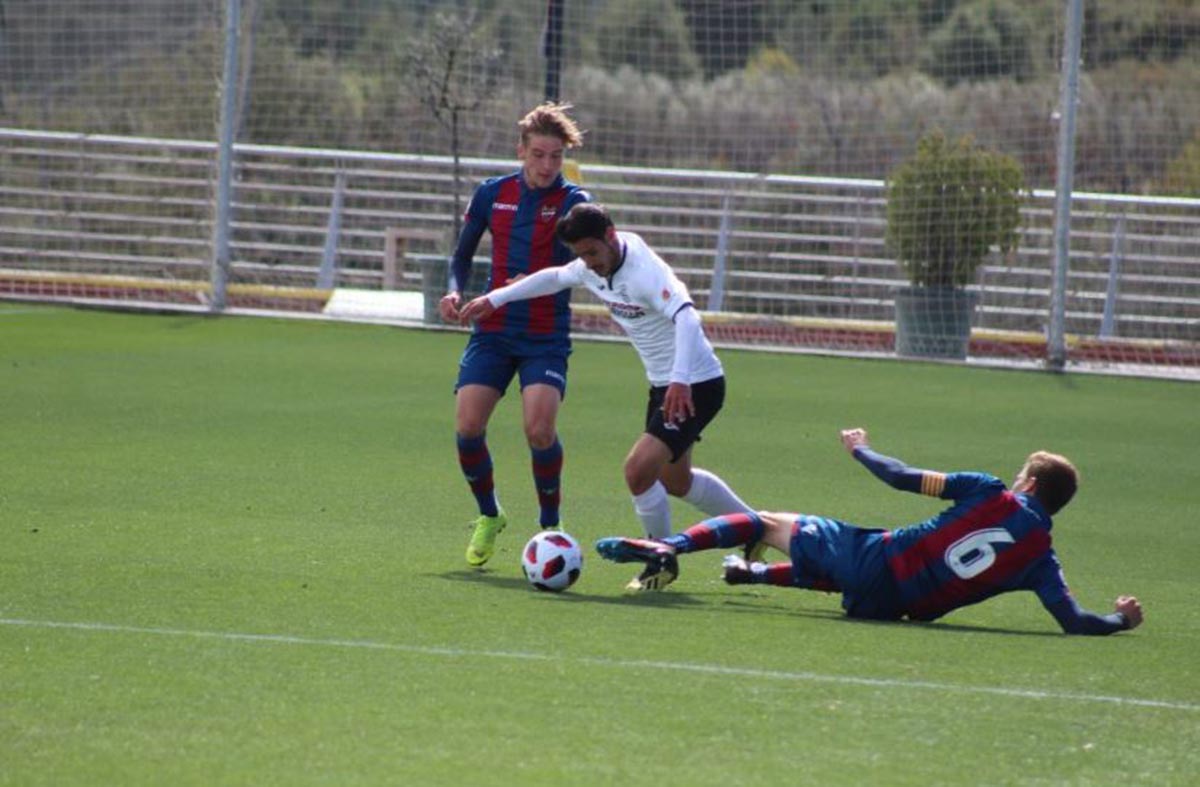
top-left (461, 203), bottom-right (752, 590)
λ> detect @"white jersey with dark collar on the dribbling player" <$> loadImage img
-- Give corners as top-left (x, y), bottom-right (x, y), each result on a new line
top-left (558, 232), bottom-right (725, 386)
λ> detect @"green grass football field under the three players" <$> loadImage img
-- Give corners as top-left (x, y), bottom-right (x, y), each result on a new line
top-left (0, 304), bottom-right (1200, 785)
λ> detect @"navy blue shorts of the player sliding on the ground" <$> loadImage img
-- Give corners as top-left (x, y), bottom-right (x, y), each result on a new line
top-left (790, 513), bottom-right (904, 620)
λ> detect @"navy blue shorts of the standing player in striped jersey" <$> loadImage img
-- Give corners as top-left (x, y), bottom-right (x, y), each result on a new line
top-left (454, 334), bottom-right (571, 398)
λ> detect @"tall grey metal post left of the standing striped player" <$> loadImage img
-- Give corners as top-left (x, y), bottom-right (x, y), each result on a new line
top-left (209, 0), bottom-right (241, 312)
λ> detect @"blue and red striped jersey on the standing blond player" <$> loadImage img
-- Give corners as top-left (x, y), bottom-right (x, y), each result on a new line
top-left (452, 170), bottom-right (592, 342)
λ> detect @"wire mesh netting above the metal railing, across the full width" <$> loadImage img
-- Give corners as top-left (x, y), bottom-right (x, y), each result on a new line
top-left (0, 0), bottom-right (1200, 193)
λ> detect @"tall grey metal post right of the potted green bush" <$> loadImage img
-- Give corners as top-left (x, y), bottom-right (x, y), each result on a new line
top-left (1046, 0), bottom-right (1084, 372)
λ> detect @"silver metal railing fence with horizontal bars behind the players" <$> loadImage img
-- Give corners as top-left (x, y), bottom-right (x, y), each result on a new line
top-left (0, 130), bottom-right (1200, 377)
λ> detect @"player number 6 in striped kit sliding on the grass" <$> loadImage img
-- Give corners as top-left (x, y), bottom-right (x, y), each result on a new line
top-left (596, 428), bottom-right (1142, 635)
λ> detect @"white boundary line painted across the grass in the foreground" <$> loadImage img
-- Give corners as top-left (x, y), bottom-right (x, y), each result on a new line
top-left (0, 618), bottom-right (1200, 711)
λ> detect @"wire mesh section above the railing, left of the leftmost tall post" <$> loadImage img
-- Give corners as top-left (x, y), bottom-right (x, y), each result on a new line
top-left (0, 0), bottom-right (223, 139)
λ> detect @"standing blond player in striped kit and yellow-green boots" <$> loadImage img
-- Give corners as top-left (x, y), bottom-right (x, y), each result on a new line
top-left (438, 102), bottom-right (590, 566)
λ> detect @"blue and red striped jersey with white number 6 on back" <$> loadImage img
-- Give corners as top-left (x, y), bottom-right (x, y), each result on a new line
top-left (884, 473), bottom-right (1069, 620)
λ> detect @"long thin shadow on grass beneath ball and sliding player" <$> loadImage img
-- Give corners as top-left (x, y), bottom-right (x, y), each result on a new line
top-left (427, 569), bottom-right (1063, 637)
